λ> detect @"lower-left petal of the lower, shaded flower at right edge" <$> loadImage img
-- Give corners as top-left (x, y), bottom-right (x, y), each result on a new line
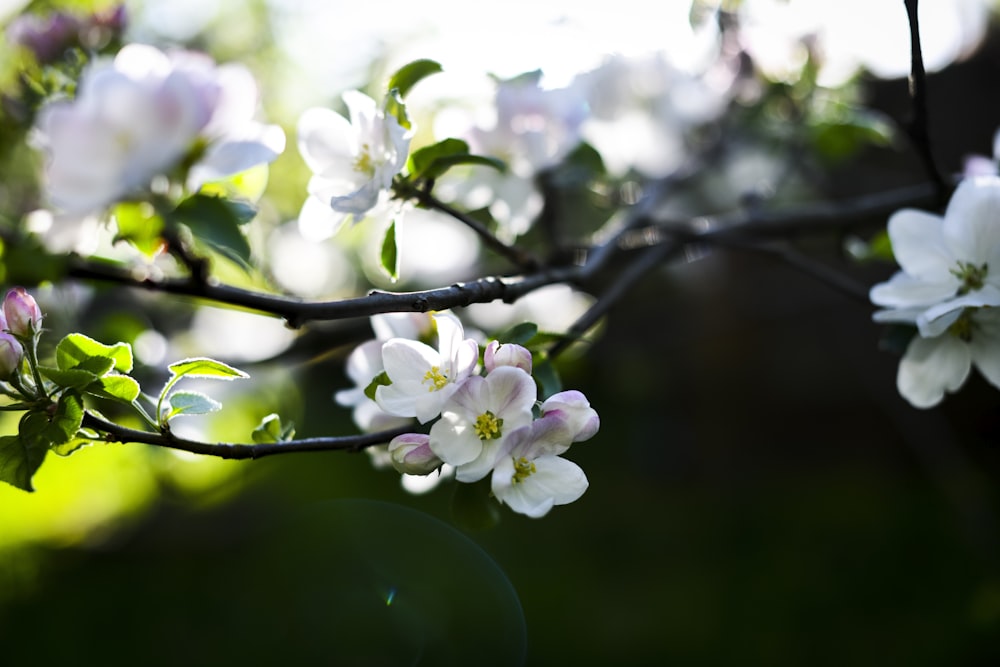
top-left (896, 334), bottom-right (972, 408)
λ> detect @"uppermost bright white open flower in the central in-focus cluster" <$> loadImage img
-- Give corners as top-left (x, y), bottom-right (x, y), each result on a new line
top-left (375, 313), bottom-right (479, 424)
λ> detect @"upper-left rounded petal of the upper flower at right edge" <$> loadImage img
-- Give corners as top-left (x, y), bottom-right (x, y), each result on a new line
top-left (889, 209), bottom-right (954, 282)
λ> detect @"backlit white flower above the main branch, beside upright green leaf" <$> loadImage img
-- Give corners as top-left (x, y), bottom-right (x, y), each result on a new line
top-left (298, 90), bottom-right (410, 237)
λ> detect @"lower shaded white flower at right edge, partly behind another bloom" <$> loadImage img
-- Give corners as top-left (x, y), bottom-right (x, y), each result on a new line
top-left (896, 308), bottom-right (1000, 408)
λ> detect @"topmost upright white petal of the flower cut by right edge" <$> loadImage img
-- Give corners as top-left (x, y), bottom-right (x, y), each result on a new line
top-left (944, 176), bottom-right (1000, 265)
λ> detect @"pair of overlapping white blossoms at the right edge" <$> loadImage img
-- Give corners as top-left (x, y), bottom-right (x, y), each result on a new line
top-left (871, 176), bottom-right (1000, 408)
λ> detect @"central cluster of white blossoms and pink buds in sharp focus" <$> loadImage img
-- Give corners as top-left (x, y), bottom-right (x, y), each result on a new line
top-left (336, 312), bottom-right (600, 517)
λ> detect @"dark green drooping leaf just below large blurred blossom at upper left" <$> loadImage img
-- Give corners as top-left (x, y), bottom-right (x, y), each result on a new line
top-left (171, 194), bottom-right (257, 266)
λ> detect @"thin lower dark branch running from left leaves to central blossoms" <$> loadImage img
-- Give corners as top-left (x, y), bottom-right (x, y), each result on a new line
top-left (83, 412), bottom-right (418, 459)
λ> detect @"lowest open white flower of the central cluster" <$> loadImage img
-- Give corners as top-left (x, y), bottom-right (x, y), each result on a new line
top-left (490, 420), bottom-right (589, 518)
